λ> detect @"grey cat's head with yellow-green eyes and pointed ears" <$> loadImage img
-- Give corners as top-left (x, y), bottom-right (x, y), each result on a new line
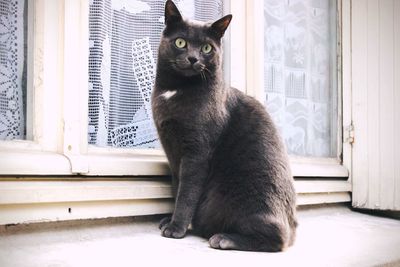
top-left (158, 0), bottom-right (232, 77)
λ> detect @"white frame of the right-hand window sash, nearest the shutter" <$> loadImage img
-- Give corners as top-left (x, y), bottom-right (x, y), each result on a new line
top-left (241, 0), bottom-right (350, 178)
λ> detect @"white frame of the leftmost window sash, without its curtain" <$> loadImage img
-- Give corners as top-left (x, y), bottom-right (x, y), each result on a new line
top-left (0, 0), bottom-right (70, 175)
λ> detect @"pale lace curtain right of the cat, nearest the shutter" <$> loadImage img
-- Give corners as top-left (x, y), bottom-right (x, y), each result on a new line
top-left (264, 0), bottom-right (337, 157)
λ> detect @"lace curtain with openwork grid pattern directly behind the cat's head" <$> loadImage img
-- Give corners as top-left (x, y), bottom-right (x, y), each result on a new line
top-left (88, 0), bottom-right (223, 148)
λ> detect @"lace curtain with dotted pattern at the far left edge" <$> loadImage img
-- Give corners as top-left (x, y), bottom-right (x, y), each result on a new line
top-left (0, 0), bottom-right (26, 140)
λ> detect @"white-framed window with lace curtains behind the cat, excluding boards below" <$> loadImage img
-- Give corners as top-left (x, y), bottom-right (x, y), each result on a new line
top-left (0, 0), bottom-right (347, 176)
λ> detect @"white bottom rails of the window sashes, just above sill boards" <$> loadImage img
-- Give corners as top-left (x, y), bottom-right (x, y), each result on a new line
top-left (0, 149), bottom-right (349, 177)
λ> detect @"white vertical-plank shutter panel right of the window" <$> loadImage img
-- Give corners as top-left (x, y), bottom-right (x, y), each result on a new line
top-left (351, 0), bottom-right (400, 210)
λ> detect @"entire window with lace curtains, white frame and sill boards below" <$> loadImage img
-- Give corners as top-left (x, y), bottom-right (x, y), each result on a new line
top-left (0, 0), bottom-right (351, 226)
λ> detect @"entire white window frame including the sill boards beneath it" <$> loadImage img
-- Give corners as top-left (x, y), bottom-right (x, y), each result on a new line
top-left (0, 0), bottom-right (351, 225)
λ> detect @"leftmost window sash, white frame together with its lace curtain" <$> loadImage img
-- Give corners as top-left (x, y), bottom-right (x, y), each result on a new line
top-left (0, 0), bottom-right (72, 175)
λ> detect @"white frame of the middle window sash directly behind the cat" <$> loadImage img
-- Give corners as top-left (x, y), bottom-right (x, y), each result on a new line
top-left (64, 0), bottom-right (234, 176)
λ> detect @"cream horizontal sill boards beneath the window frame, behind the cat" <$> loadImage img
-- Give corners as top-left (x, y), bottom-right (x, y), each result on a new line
top-left (0, 176), bottom-right (351, 225)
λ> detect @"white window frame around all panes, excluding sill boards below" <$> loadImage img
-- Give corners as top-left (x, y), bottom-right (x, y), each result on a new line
top-left (0, 0), bottom-right (350, 180)
